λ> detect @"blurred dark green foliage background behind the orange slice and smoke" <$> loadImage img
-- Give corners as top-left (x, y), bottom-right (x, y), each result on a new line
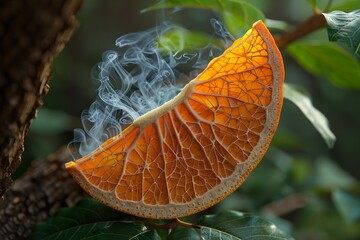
top-left (26, 0), bottom-right (360, 239)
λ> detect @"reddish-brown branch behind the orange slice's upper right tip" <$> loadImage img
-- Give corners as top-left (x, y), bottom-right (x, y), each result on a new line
top-left (275, 13), bottom-right (326, 49)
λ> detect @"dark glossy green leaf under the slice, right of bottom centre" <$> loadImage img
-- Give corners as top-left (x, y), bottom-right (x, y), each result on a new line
top-left (198, 211), bottom-right (293, 240)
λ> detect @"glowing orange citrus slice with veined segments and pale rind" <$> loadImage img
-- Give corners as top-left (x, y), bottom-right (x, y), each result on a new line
top-left (66, 21), bottom-right (284, 219)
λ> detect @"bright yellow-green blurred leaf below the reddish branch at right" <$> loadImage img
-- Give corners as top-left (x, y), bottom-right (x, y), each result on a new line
top-left (286, 41), bottom-right (360, 89)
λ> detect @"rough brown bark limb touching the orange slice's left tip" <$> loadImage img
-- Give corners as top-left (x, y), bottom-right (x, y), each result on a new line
top-left (0, 148), bottom-right (83, 240)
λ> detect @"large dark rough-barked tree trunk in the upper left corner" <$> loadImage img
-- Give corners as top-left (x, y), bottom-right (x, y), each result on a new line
top-left (0, 0), bottom-right (82, 198)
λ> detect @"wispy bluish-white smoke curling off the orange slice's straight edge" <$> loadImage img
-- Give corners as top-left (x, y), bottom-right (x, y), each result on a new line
top-left (69, 20), bottom-right (233, 159)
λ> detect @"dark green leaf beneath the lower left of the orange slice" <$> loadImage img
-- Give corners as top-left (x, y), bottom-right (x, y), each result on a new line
top-left (29, 198), bottom-right (159, 240)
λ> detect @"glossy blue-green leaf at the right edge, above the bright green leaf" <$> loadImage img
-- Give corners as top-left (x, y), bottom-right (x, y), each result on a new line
top-left (323, 10), bottom-right (360, 58)
